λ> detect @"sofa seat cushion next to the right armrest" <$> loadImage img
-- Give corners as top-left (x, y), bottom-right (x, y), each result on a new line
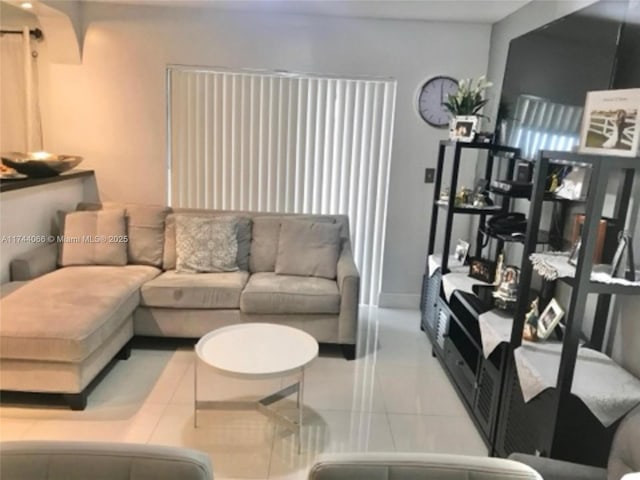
top-left (240, 272), bottom-right (340, 314)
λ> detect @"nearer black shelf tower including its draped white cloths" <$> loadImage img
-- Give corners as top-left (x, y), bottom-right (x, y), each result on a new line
top-left (495, 151), bottom-right (640, 467)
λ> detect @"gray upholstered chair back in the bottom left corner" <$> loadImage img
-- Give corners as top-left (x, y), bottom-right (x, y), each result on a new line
top-left (0, 441), bottom-right (213, 480)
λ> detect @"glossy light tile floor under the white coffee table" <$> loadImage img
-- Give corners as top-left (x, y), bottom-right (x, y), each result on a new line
top-left (0, 308), bottom-right (487, 480)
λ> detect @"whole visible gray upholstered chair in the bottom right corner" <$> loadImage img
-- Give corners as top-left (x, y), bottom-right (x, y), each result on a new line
top-left (509, 405), bottom-right (640, 480)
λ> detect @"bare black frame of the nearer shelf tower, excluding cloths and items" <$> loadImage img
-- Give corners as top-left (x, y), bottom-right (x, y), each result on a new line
top-left (496, 151), bottom-right (640, 466)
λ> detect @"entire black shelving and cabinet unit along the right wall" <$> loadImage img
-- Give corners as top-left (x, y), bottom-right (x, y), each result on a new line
top-left (421, 141), bottom-right (640, 466)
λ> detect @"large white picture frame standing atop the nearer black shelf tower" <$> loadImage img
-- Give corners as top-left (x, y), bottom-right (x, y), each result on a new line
top-left (579, 88), bottom-right (640, 157)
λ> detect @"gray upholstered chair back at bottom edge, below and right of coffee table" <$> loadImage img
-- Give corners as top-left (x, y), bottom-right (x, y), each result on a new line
top-left (309, 453), bottom-right (546, 480)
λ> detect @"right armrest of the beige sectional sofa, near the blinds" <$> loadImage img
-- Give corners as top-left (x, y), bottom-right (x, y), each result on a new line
top-left (337, 240), bottom-right (360, 345)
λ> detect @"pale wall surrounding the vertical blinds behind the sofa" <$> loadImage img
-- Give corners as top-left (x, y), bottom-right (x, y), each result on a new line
top-left (37, 2), bottom-right (490, 308)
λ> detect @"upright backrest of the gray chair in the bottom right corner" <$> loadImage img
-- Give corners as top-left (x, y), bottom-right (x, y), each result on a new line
top-left (607, 405), bottom-right (640, 480)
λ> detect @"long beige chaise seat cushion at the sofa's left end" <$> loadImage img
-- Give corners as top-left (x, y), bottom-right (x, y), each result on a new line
top-left (0, 265), bottom-right (160, 362)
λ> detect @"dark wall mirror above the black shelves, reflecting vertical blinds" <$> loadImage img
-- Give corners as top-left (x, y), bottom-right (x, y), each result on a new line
top-left (498, 0), bottom-right (640, 158)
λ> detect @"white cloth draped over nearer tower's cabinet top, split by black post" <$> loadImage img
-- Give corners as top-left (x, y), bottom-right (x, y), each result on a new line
top-left (514, 342), bottom-right (640, 427)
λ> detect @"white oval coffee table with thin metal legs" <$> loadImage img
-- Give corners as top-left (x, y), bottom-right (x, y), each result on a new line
top-left (193, 323), bottom-right (318, 451)
